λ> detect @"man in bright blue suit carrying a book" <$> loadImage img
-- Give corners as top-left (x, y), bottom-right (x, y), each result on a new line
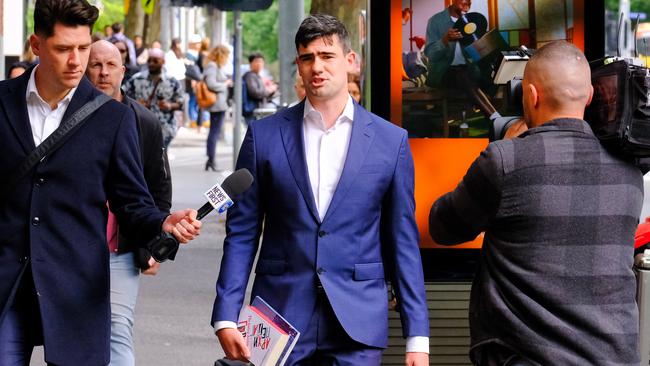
top-left (212, 15), bottom-right (429, 365)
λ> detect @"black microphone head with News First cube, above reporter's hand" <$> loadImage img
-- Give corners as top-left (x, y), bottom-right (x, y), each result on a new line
top-left (196, 168), bottom-right (253, 220)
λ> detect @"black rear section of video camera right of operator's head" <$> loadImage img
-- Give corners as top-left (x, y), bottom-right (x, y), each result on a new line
top-left (585, 59), bottom-right (650, 158)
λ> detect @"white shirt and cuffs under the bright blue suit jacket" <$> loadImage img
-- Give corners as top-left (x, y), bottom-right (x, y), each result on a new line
top-left (214, 97), bottom-right (429, 353)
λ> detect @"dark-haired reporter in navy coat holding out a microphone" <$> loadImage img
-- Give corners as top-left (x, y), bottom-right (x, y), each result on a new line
top-left (0, 0), bottom-right (200, 366)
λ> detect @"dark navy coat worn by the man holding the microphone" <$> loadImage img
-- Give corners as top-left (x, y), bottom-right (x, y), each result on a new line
top-left (0, 70), bottom-right (165, 365)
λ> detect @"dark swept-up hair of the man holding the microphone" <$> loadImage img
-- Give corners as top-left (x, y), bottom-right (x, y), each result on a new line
top-left (34, 0), bottom-right (99, 38)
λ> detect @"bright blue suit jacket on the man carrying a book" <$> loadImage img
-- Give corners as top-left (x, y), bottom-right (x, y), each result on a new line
top-left (212, 102), bottom-right (429, 347)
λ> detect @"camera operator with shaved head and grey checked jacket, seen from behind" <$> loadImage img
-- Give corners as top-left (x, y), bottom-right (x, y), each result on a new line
top-left (429, 42), bottom-right (643, 365)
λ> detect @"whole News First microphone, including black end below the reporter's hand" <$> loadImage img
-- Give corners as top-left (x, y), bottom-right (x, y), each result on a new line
top-left (147, 168), bottom-right (253, 263)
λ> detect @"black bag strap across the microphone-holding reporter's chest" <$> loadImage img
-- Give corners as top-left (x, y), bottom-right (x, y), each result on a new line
top-left (0, 93), bottom-right (112, 203)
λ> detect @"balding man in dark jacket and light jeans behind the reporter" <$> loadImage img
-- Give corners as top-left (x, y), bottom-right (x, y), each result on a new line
top-left (86, 40), bottom-right (172, 366)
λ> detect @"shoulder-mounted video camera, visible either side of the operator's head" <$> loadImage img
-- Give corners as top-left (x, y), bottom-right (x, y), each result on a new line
top-left (490, 46), bottom-right (650, 158)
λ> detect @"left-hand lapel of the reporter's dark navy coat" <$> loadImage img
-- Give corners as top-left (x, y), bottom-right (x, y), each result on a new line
top-left (0, 69), bottom-right (36, 154)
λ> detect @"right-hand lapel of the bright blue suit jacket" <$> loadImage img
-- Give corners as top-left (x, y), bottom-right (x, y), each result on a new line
top-left (323, 103), bottom-right (375, 222)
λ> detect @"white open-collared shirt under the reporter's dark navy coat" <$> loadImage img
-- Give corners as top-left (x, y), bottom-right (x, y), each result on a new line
top-left (25, 66), bottom-right (77, 146)
